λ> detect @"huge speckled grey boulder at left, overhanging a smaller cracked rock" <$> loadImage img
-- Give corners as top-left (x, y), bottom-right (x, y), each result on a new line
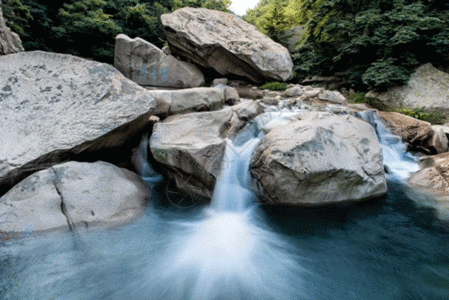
top-left (0, 51), bottom-right (157, 195)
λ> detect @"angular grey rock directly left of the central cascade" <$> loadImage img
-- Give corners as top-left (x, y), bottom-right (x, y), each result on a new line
top-left (150, 101), bottom-right (263, 198)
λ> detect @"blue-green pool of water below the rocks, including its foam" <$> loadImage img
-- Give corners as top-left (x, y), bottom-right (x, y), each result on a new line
top-left (0, 181), bottom-right (449, 300)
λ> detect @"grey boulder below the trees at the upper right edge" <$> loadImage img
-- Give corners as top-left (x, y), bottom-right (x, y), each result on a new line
top-left (366, 63), bottom-right (449, 122)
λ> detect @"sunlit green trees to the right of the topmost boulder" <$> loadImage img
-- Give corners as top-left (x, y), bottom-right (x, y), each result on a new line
top-left (244, 0), bottom-right (449, 89)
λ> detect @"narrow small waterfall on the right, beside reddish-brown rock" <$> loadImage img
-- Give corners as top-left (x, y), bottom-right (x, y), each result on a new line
top-left (358, 110), bottom-right (419, 181)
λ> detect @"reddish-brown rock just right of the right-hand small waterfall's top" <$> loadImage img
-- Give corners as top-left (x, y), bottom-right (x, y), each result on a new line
top-left (379, 112), bottom-right (448, 154)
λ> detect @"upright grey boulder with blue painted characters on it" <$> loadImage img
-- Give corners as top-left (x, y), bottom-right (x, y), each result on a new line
top-left (114, 34), bottom-right (204, 88)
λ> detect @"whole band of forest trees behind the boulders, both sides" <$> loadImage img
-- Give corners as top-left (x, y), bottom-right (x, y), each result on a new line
top-left (3, 0), bottom-right (449, 90)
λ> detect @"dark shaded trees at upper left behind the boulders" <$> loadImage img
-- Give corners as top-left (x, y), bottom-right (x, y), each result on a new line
top-left (2, 0), bottom-right (231, 62)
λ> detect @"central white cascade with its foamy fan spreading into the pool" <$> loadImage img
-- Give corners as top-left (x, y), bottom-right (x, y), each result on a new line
top-left (140, 119), bottom-right (304, 299)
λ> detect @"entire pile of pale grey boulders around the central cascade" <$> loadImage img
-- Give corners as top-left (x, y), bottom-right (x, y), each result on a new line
top-left (0, 8), bottom-right (448, 236)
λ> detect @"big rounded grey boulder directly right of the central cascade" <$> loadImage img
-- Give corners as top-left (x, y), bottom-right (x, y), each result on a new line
top-left (251, 112), bottom-right (387, 205)
